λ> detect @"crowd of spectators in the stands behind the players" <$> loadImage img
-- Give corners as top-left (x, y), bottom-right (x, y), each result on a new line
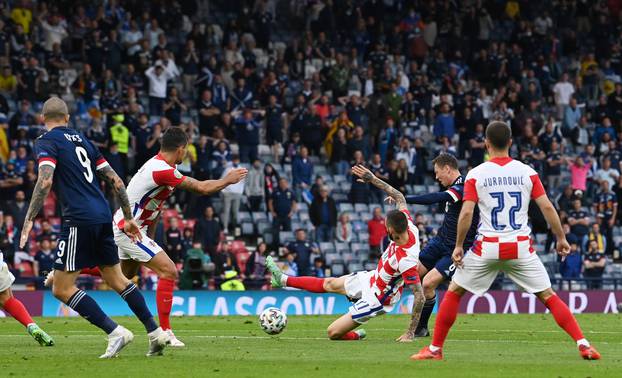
top-left (0, 0), bottom-right (622, 289)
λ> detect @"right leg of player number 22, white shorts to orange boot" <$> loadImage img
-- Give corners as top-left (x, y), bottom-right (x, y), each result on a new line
top-left (504, 254), bottom-right (600, 360)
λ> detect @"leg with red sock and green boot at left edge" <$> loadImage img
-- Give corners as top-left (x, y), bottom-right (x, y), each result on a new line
top-left (0, 284), bottom-right (54, 346)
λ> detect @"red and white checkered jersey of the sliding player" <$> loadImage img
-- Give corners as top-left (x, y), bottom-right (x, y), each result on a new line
top-left (369, 210), bottom-right (421, 305)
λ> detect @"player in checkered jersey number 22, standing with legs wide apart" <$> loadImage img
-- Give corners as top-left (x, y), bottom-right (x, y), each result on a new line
top-left (411, 121), bottom-right (600, 360)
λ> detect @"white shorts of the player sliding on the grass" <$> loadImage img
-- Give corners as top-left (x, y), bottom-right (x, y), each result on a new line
top-left (344, 271), bottom-right (393, 324)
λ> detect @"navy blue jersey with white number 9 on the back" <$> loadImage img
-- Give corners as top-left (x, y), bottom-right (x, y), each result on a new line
top-left (35, 127), bottom-right (112, 225)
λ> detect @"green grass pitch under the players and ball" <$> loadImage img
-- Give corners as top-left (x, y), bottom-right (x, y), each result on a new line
top-left (0, 314), bottom-right (622, 378)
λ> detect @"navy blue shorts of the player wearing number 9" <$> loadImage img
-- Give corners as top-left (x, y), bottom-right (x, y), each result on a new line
top-left (54, 222), bottom-right (119, 272)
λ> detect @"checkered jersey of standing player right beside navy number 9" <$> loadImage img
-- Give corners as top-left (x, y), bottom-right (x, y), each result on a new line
top-left (114, 154), bottom-right (186, 230)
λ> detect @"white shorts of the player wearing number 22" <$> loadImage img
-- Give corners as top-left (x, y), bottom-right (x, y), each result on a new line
top-left (453, 253), bottom-right (551, 295)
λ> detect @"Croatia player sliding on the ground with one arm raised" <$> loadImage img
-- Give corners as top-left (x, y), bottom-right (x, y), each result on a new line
top-left (266, 165), bottom-right (425, 342)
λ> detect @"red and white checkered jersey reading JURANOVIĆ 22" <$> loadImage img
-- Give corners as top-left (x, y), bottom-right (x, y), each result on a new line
top-left (463, 157), bottom-right (546, 259)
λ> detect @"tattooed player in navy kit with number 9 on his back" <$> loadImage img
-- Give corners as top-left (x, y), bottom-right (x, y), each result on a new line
top-left (20, 97), bottom-right (170, 358)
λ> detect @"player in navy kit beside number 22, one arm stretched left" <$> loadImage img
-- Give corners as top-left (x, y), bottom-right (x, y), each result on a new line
top-left (390, 153), bottom-right (479, 337)
